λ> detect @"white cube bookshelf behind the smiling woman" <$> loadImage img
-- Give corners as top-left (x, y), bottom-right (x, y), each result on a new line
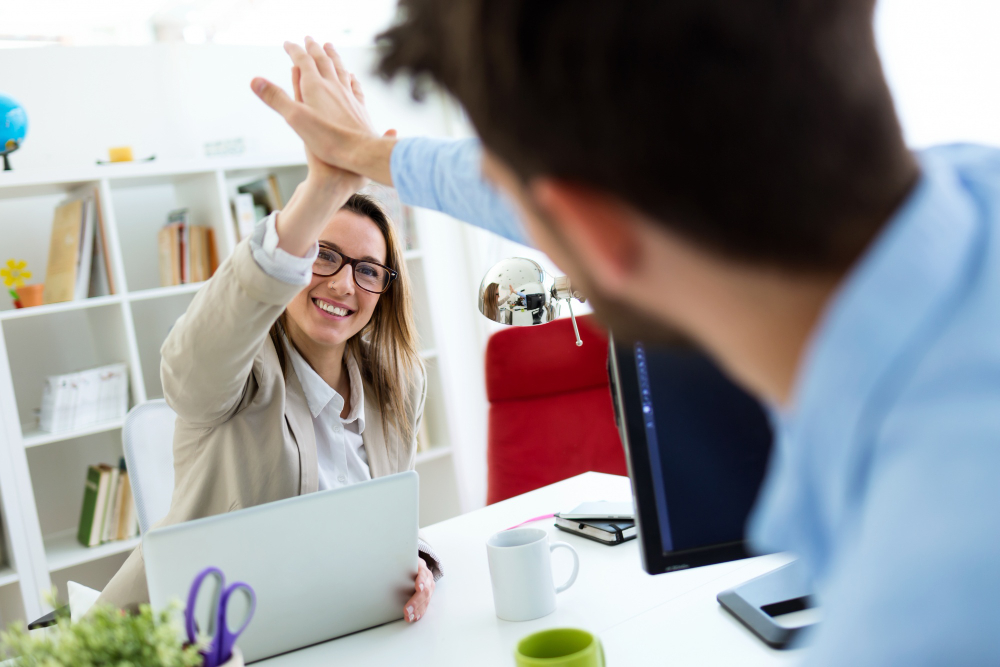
top-left (0, 158), bottom-right (459, 629)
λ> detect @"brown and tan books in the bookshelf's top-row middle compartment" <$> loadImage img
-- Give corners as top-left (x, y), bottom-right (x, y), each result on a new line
top-left (158, 208), bottom-right (219, 287)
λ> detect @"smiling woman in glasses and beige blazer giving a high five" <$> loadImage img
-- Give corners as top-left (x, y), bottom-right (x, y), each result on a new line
top-left (100, 41), bottom-right (442, 622)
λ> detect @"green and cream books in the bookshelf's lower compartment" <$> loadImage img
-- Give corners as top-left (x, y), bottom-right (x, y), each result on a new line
top-left (76, 459), bottom-right (139, 547)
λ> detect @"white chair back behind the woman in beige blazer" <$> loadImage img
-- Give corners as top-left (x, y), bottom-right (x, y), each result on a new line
top-left (122, 398), bottom-right (177, 535)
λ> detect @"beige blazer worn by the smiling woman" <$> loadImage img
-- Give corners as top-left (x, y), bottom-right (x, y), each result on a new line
top-left (98, 241), bottom-right (441, 608)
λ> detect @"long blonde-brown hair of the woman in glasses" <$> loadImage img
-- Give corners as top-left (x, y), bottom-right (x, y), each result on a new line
top-left (271, 194), bottom-right (420, 442)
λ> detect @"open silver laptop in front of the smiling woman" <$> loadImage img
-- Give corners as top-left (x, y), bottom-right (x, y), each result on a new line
top-left (142, 471), bottom-right (418, 662)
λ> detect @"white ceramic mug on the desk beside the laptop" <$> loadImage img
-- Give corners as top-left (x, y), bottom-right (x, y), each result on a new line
top-left (486, 528), bottom-right (580, 621)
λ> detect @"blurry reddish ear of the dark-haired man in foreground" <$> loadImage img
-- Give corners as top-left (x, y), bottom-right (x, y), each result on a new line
top-left (528, 178), bottom-right (641, 293)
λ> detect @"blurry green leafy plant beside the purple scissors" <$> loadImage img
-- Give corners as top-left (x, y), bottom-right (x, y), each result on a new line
top-left (0, 605), bottom-right (233, 667)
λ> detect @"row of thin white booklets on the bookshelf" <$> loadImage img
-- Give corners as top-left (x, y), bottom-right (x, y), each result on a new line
top-left (39, 364), bottom-right (128, 433)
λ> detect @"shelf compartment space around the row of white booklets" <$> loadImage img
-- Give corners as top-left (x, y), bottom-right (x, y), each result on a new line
top-left (0, 297), bottom-right (129, 430)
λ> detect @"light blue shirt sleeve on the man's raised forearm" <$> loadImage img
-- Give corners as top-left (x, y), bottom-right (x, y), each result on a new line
top-left (389, 138), bottom-right (531, 245)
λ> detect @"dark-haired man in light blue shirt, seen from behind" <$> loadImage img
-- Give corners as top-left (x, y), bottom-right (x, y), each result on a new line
top-left (253, 0), bottom-right (1000, 665)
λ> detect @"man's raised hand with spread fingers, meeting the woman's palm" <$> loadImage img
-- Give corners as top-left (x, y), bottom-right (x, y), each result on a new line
top-left (251, 37), bottom-right (378, 171)
